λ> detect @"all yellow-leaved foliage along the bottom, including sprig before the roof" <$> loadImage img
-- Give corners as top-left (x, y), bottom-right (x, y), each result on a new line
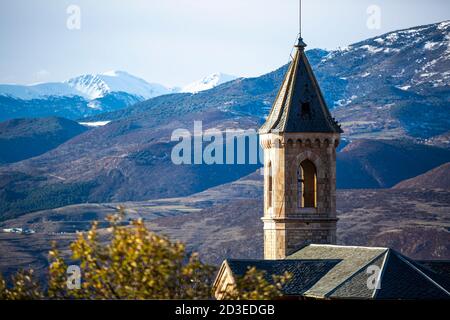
top-left (0, 209), bottom-right (285, 299)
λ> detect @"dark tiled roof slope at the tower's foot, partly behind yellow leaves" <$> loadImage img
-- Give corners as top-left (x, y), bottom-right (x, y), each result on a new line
top-left (226, 259), bottom-right (339, 296)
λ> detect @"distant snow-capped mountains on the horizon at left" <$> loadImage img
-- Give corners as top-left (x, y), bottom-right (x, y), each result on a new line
top-left (0, 71), bottom-right (236, 120)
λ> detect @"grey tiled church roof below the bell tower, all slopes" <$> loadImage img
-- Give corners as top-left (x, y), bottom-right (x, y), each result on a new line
top-left (222, 244), bottom-right (450, 299)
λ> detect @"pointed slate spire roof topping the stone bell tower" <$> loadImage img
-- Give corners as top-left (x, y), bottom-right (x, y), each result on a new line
top-left (259, 38), bottom-right (342, 133)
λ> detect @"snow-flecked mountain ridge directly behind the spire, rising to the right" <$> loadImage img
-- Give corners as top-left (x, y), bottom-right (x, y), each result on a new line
top-left (83, 21), bottom-right (450, 139)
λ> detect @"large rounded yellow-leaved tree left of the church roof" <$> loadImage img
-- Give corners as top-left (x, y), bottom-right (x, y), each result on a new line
top-left (49, 210), bottom-right (213, 299)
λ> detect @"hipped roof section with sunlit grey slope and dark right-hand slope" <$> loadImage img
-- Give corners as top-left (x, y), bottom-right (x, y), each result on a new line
top-left (287, 244), bottom-right (450, 299)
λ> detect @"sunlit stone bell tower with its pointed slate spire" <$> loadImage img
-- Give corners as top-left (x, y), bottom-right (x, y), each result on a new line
top-left (259, 37), bottom-right (342, 259)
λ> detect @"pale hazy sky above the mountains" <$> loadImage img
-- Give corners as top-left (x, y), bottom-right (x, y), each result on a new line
top-left (0, 0), bottom-right (450, 86)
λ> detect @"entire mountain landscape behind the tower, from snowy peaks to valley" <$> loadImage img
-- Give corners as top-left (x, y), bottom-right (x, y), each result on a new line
top-left (0, 21), bottom-right (450, 275)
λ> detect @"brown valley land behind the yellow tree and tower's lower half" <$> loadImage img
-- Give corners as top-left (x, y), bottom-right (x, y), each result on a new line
top-left (0, 171), bottom-right (450, 277)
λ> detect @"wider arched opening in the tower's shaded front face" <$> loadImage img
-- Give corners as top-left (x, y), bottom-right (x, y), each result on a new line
top-left (297, 160), bottom-right (317, 208)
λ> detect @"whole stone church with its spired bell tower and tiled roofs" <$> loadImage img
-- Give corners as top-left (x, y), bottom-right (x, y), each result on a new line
top-left (213, 37), bottom-right (450, 299)
